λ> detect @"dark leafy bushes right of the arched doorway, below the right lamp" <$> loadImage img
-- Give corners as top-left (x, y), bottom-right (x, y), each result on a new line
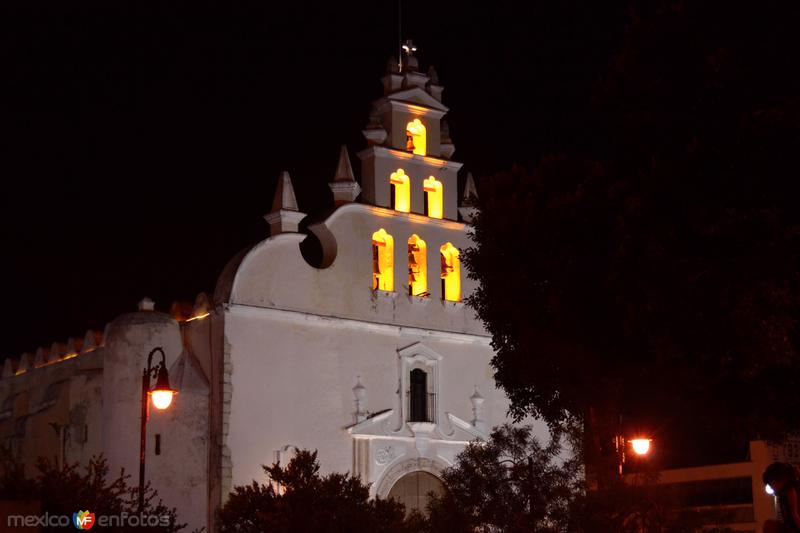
top-left (432, 425), bottom-right (720, 533)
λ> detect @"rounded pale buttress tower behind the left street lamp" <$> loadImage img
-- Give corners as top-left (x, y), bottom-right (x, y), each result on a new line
top-left (103, 311), bottom-right (208, 530)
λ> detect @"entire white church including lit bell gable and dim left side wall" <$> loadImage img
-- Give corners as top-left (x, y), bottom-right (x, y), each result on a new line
top-left (0, 51), bottom-right (520, 531)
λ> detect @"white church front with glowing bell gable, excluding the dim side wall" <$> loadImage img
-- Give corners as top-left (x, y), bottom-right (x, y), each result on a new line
top-left (212, 48), bottom-right (508, 505)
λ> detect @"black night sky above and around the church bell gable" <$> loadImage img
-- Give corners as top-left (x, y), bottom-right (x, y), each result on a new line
top-left (0, 0), bottom-right (627, 357)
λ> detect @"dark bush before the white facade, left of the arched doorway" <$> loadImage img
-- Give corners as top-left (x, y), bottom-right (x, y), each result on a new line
top-left (219, 450), bottom-right (421, 533)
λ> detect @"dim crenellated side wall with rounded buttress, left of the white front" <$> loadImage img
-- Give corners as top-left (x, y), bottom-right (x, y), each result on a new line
top-left (0, 295), bottom-right (213, 530)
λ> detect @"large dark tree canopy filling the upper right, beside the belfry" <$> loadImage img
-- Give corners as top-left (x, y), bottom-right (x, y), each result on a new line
top-left (465, 0), bottom-right (800, 462)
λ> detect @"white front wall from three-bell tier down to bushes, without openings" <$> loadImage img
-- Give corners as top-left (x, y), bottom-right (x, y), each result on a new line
top-left (223, 204), bottom-right (552, 496)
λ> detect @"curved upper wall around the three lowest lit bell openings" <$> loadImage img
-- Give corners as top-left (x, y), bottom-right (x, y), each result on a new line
top-left (230, 204), bottom-right (486, 330)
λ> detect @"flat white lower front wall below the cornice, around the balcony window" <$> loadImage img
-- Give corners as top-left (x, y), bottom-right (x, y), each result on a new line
top-left (227, 307), bottom-right (507, 484)
